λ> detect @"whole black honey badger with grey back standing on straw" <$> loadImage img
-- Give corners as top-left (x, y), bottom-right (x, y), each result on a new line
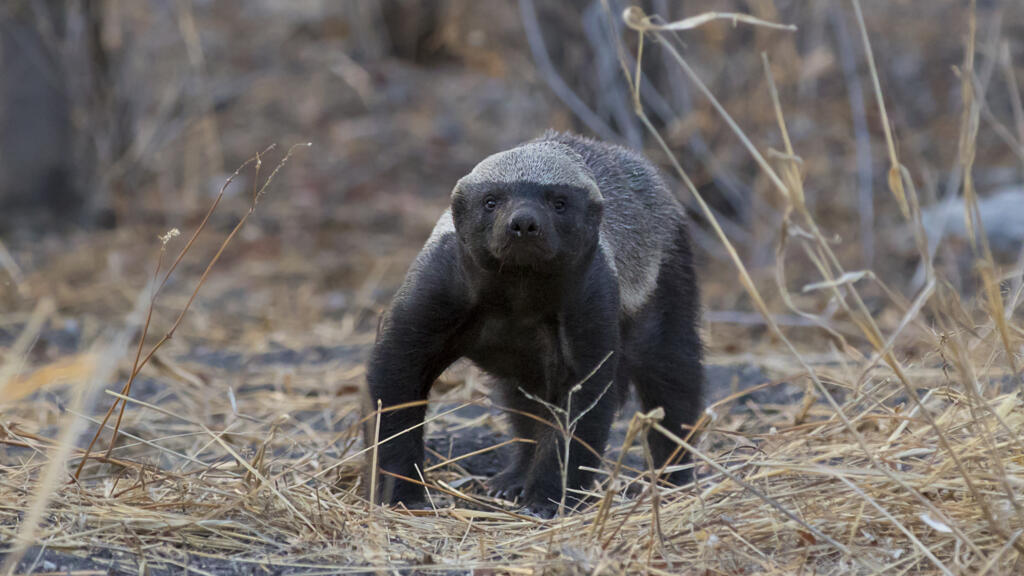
top-left (367, 132), bottom-right (703, 516)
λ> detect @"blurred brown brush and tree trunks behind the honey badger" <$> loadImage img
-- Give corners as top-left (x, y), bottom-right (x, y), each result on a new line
top-left (0, 0), bottom-right (1024, 306)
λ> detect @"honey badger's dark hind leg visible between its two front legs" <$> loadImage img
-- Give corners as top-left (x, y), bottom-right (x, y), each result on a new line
top-left (486, 379), bottom-right (544, 500)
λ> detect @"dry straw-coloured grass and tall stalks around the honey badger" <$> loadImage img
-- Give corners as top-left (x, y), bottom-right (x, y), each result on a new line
top-left (0, 2), bottom-right (1024, 574)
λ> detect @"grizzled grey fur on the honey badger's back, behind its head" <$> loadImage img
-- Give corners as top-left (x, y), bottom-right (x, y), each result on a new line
top-left (534, 131), bottom-right (686, 314)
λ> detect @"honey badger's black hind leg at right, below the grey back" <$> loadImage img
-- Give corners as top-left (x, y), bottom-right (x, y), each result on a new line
top-left (626, 224), bottom-right (703, 485)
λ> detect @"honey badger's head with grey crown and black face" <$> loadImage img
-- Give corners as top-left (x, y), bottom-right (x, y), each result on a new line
top-left (452, 141), bottom-right (603, 272)
